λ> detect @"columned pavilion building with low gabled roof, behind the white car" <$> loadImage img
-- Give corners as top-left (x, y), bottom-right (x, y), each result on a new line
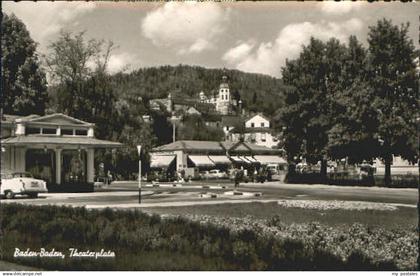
top-left (1, 113), bottom-right (122, 185)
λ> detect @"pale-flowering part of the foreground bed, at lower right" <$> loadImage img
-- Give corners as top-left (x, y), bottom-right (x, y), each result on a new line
top-left (188, 215), bottom-right (418, 270)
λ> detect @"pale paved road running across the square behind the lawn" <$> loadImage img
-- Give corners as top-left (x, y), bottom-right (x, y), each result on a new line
top-left (3, 181), bottom-right (418, 208)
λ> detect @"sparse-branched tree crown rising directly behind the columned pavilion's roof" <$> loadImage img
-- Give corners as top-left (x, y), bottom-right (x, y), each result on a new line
top-left (45, 31), bottom-right (113, 119)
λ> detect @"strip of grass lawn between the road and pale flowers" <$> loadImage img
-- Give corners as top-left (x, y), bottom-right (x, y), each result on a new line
top-left (144, 202), bottom-right (417, 229)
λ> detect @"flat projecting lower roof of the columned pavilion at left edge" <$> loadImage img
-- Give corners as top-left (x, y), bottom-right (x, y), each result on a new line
top-left (1, 135), bottom-right (123, 148)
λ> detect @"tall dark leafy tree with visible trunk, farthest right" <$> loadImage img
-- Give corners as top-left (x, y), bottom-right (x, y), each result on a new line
top-left (368, 19), bottom-right (419, 184)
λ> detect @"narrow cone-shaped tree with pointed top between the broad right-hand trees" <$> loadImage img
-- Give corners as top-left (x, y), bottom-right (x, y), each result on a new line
top-left (328, 36), bottom-right (379, 163)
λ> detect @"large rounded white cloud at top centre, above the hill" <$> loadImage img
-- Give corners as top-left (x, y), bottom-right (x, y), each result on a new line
top-left (141, 2), bottom-right (229, 54)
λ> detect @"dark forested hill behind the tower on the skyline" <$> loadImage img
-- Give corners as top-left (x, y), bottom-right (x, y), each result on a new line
top-left (112, 65), bottom-right (286, 116)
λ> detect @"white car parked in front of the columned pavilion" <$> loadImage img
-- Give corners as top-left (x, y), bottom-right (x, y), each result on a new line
top-left (0, 172), bottom-right (48, 199)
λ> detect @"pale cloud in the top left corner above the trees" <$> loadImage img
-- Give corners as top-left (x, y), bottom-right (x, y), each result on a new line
top-left (3, 1), bottom-right (95, 49)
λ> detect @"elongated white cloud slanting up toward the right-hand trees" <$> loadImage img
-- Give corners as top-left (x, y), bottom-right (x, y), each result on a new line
top-left (223, 18), bottom-right (363, 76)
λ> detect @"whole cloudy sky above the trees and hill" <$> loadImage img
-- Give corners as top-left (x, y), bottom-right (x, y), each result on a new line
top-left (3, 2), bottom-right (420, 77)
